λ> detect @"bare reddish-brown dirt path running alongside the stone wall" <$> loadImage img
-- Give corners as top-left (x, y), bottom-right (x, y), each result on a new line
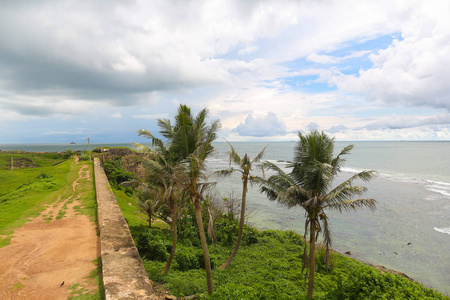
top-left (0, 165), bottom-right (98, 300)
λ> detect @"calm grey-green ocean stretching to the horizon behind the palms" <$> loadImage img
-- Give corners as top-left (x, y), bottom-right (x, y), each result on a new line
top-left (0, 142), bottom-right (450, 295)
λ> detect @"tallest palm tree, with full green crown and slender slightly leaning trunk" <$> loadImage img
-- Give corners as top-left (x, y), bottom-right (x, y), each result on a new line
top-left (139, 105), bottom-right (220, 294)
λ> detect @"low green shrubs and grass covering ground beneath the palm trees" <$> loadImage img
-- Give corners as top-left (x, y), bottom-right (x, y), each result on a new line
top-left (114, 186), bottom-right (449, 300)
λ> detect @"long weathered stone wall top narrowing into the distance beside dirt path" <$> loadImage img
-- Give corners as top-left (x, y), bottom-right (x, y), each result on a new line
top-left (94, 158), bottom-right (159, 300)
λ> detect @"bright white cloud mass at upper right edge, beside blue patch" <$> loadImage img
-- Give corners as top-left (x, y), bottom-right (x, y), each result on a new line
top-left (336, 1), bottom-right (450, 110)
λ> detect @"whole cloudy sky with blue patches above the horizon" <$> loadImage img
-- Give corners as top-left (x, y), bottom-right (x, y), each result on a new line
top-left (0, 0), bottom-right (450, 143)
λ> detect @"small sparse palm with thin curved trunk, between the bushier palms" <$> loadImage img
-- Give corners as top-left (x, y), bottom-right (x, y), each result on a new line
top-left (215, 142), bottom-right (268, 269)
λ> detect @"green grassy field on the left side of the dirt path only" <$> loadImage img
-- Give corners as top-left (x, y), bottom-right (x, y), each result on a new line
top-left (0, 152), bottom-right (70, 241)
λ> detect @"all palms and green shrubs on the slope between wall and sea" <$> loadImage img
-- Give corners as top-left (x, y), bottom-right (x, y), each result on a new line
top-left (105, 105), bottom-right (448, 299)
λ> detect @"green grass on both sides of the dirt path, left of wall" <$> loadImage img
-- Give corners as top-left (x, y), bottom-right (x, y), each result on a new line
top-left (0, 152), bottom-right (104, 300)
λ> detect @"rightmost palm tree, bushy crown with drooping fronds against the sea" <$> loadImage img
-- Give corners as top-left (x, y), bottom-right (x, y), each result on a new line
top-left (260, 131), bottom-right (376, 298)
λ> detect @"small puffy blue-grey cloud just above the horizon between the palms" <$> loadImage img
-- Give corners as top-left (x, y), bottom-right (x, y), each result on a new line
top-left (235, 112), bottom-right (287, 137)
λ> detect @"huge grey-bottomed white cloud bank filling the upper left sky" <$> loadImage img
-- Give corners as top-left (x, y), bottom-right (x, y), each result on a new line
top-left (0, 0), bottom-right (302, 110)
